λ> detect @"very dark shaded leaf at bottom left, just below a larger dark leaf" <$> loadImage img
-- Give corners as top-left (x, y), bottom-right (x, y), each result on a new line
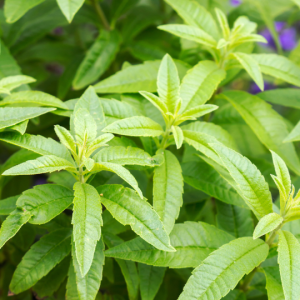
top-left (33, 256), bottom-right (70, 297)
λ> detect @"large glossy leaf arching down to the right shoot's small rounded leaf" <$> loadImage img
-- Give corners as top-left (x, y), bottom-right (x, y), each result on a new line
top-left (211, 144), bottom-right (273, 219)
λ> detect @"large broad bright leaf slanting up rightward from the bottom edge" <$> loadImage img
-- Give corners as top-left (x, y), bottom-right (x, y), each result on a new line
top-left (178, 237), bottom-right (269, 300)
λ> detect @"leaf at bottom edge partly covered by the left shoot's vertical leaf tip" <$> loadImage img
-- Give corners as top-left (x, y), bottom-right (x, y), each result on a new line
top-left (71, 239), bottom-right (105, 300)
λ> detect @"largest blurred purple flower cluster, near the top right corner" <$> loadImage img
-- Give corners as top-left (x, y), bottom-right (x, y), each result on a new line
top-left (259, 22), bottom-right (297, 51)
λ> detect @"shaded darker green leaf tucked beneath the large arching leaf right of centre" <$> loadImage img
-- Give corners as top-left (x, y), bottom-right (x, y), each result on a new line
top-left (182, 160), bottom-right (248, 208)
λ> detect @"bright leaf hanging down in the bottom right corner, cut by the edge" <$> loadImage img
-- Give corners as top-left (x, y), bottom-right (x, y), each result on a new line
top-left (278, 230), bottom-right (300, 300)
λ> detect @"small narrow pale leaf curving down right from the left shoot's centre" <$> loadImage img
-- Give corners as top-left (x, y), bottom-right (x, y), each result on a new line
top-left (91, 162), bottom-right (143, 199)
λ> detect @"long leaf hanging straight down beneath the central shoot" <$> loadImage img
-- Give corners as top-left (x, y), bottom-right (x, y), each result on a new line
top-left (153, 150), bottom-right (183, 233)
